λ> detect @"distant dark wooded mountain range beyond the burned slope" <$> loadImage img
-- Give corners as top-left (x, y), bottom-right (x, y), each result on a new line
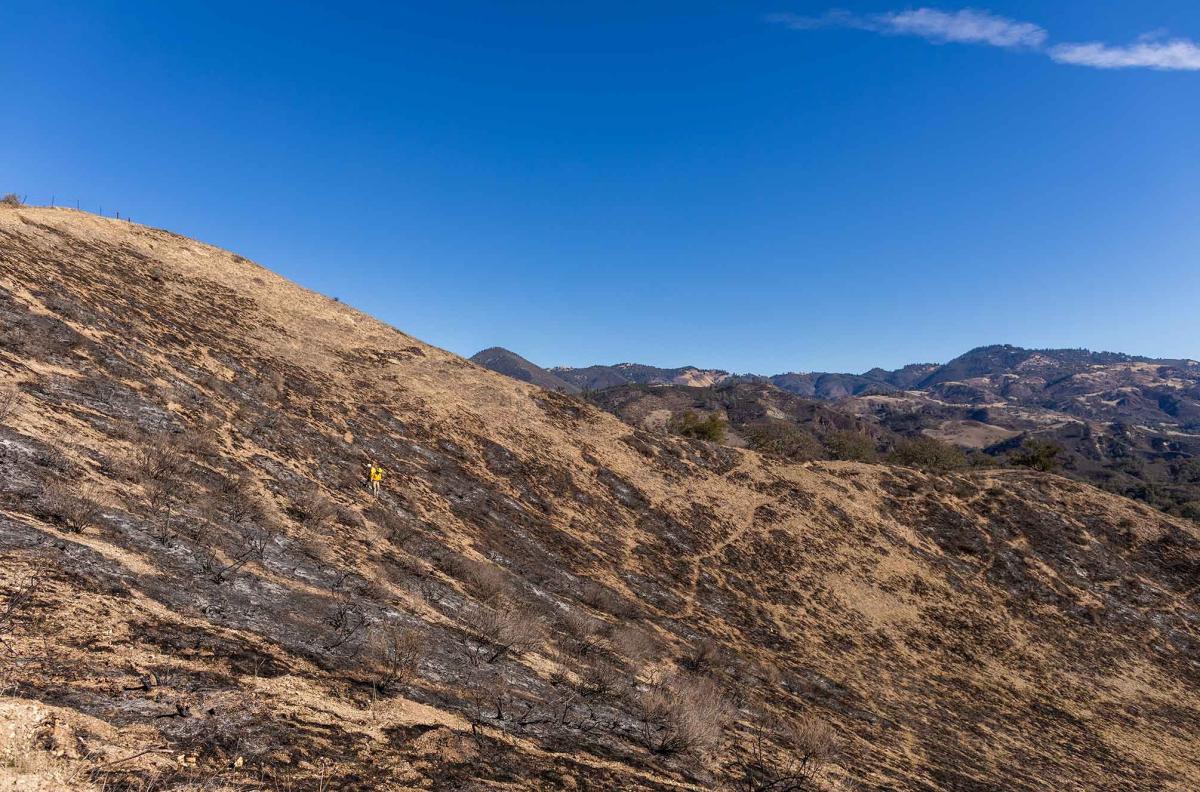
top-left (473, 344), bottom-right (1200, 518)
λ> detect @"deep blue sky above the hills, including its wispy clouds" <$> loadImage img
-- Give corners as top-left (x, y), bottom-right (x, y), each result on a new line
top-left (0, 0), bottom-right (1200, 373)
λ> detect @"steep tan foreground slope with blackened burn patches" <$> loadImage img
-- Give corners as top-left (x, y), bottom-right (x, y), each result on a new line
top-left (0, 209), bottom-right (1200, 791)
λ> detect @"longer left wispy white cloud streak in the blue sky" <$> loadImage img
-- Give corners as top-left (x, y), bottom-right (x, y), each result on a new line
top-left (768, 8), bottom-right (1046, 47)
